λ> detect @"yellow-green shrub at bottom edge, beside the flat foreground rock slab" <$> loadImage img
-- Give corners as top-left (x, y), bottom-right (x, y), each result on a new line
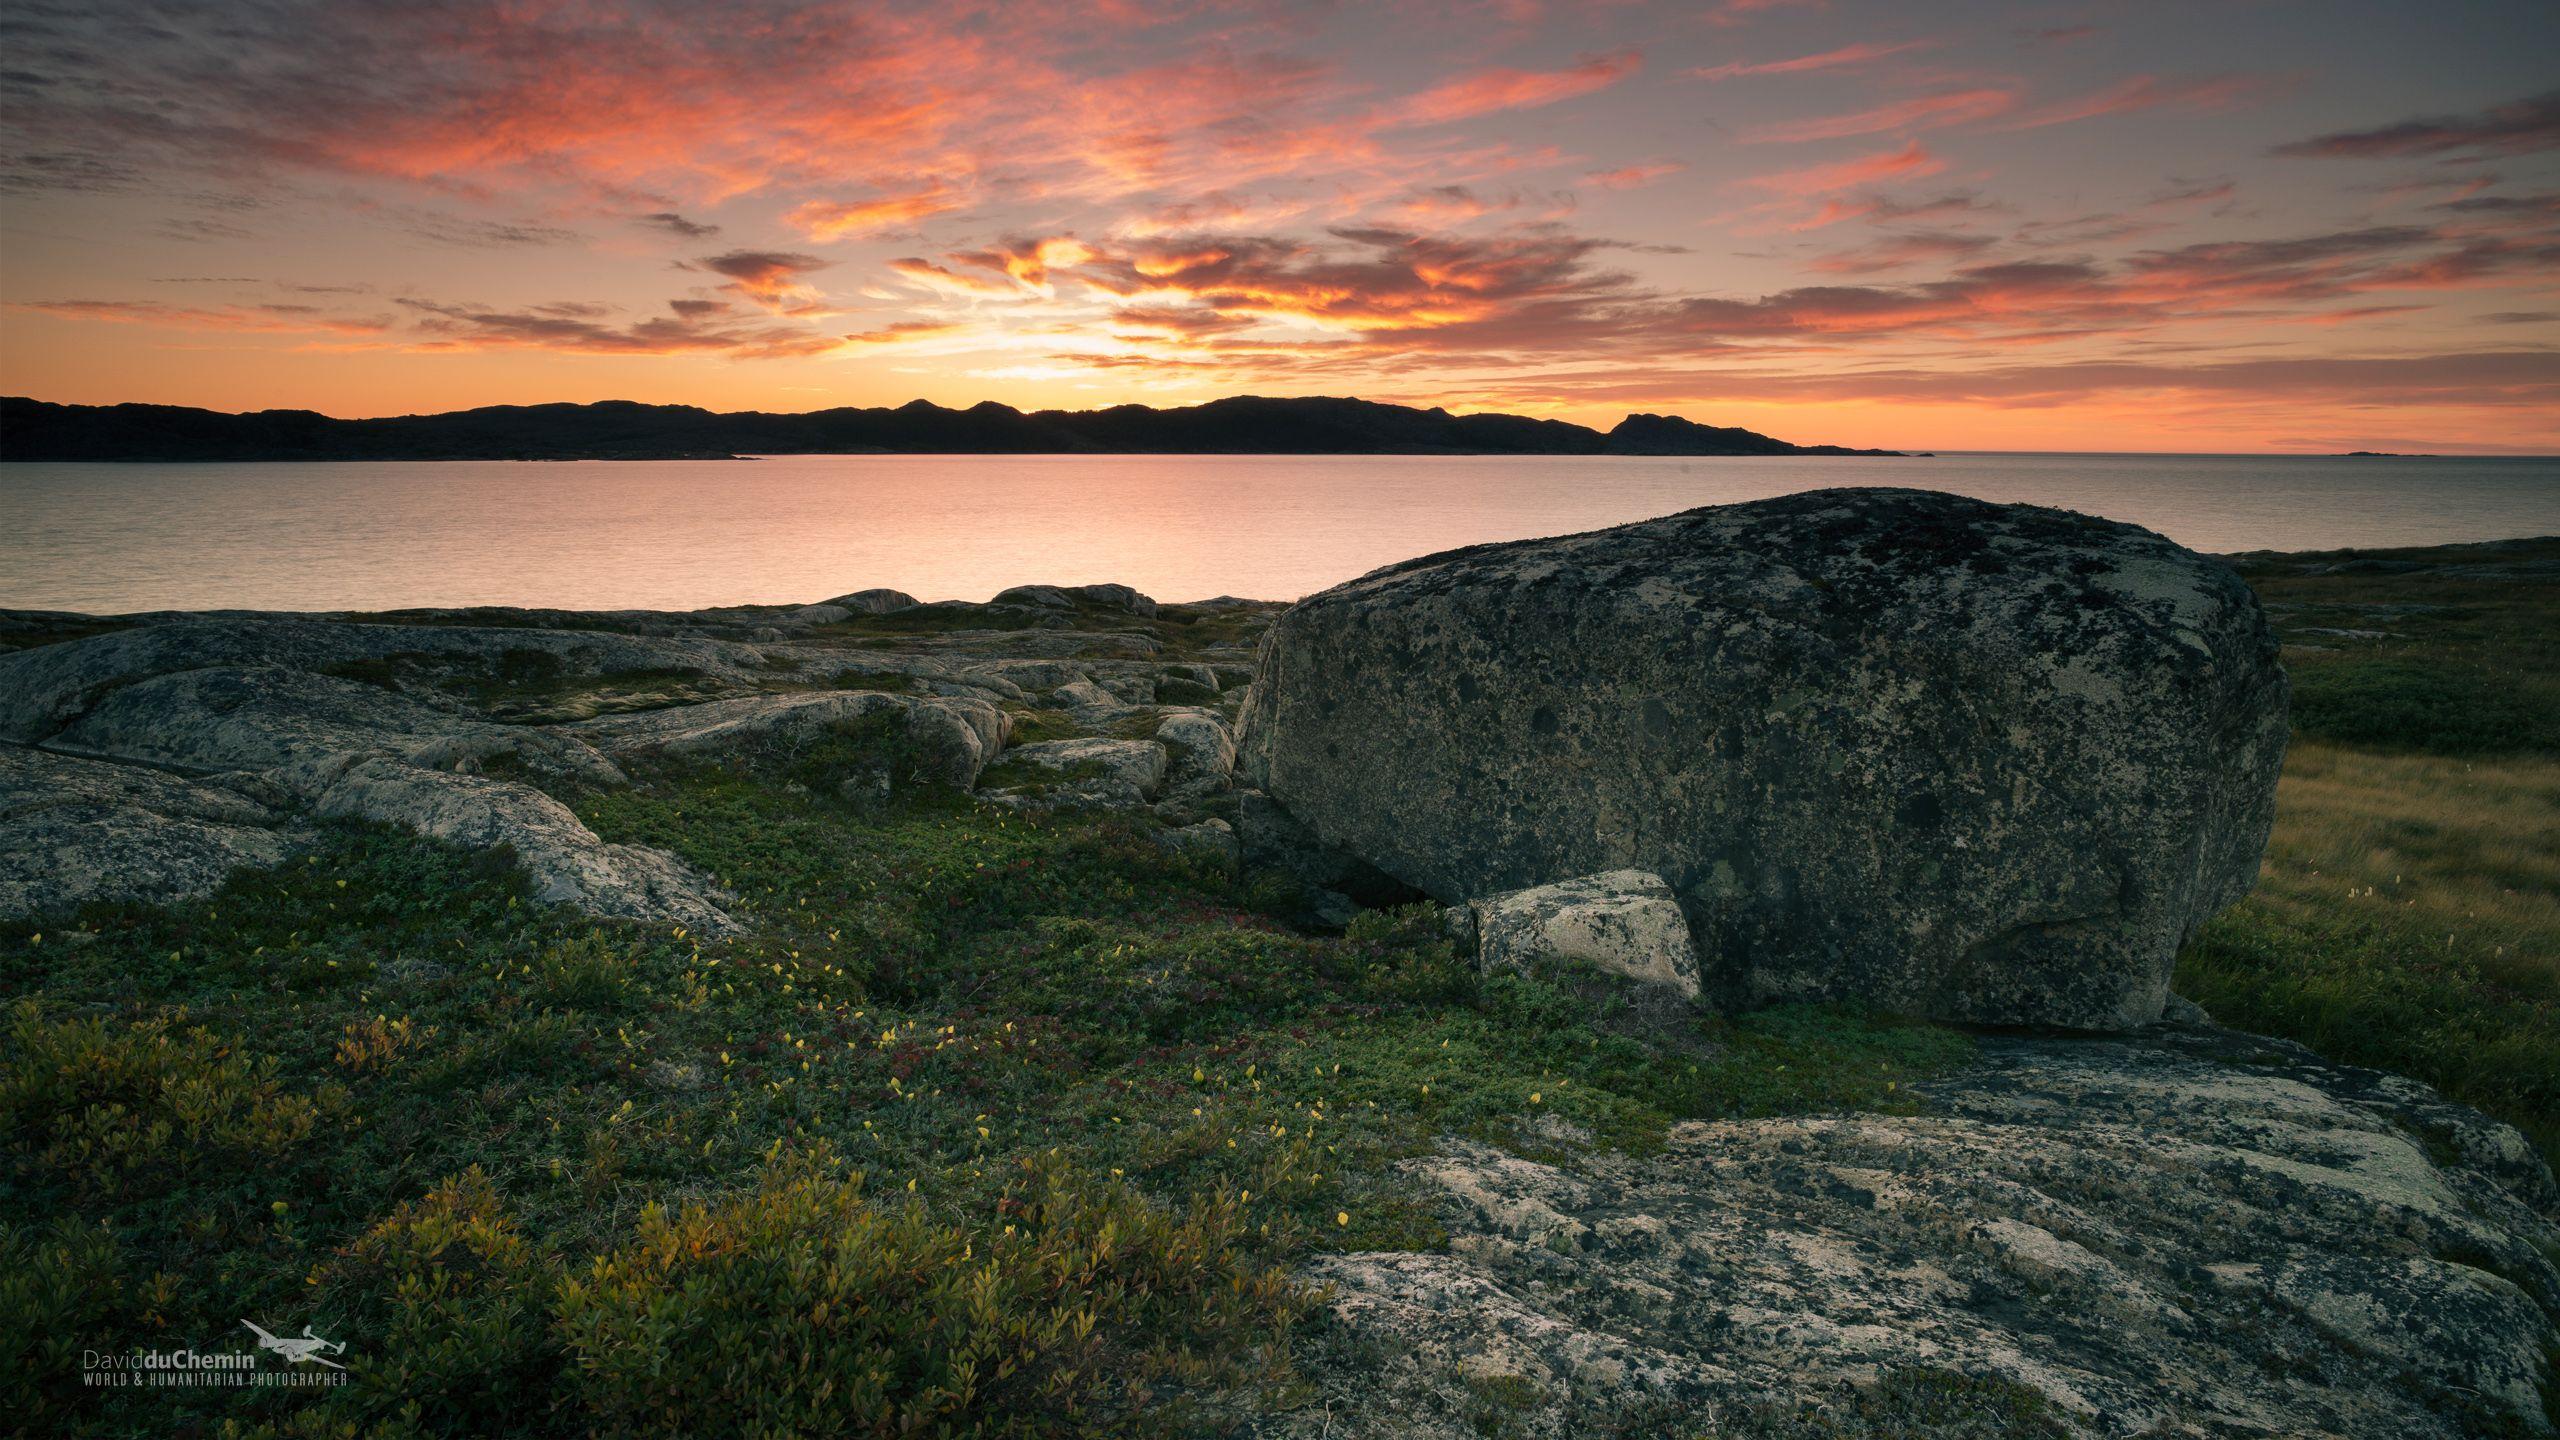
top-left (553, 1161), bottom-right (1306, 1437)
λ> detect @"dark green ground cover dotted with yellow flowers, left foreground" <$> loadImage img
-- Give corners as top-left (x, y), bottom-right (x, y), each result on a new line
top-left (0, 732), bottom-right (1969, 1435)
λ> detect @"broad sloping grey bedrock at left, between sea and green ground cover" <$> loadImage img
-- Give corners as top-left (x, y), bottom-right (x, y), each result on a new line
top-left (0, 618), bottom-right (763, 917)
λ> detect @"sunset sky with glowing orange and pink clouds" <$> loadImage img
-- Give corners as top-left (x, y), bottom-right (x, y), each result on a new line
top-left (0, 0), bottom-right (2560, 454)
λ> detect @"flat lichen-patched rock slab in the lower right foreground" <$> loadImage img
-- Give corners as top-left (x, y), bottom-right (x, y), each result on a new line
top-left (1290, 1030), bottom-right (2560, 1440)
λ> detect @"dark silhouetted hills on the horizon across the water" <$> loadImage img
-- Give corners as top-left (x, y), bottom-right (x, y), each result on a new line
top-left (0, 395), bottom-right (1897, 461)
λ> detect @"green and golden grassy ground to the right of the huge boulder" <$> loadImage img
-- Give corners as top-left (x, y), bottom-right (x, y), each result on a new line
top-left (2179, 541), bottom-right (2560, 1158)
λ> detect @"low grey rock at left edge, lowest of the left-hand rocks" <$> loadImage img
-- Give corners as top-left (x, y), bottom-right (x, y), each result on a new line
top-left (0, 746), bottom-right (300, 915)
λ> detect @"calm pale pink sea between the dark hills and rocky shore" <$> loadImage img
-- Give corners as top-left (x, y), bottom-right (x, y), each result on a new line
top-left (0, 454), bottom-right (2560, 612)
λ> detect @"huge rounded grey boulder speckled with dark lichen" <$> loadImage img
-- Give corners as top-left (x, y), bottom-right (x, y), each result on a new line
top-left (1242, 489), bottom-right (2286, 1027)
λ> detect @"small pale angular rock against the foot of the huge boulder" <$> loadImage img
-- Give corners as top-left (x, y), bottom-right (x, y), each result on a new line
top-left (1464, 871), bottom-right (1697, 999)
